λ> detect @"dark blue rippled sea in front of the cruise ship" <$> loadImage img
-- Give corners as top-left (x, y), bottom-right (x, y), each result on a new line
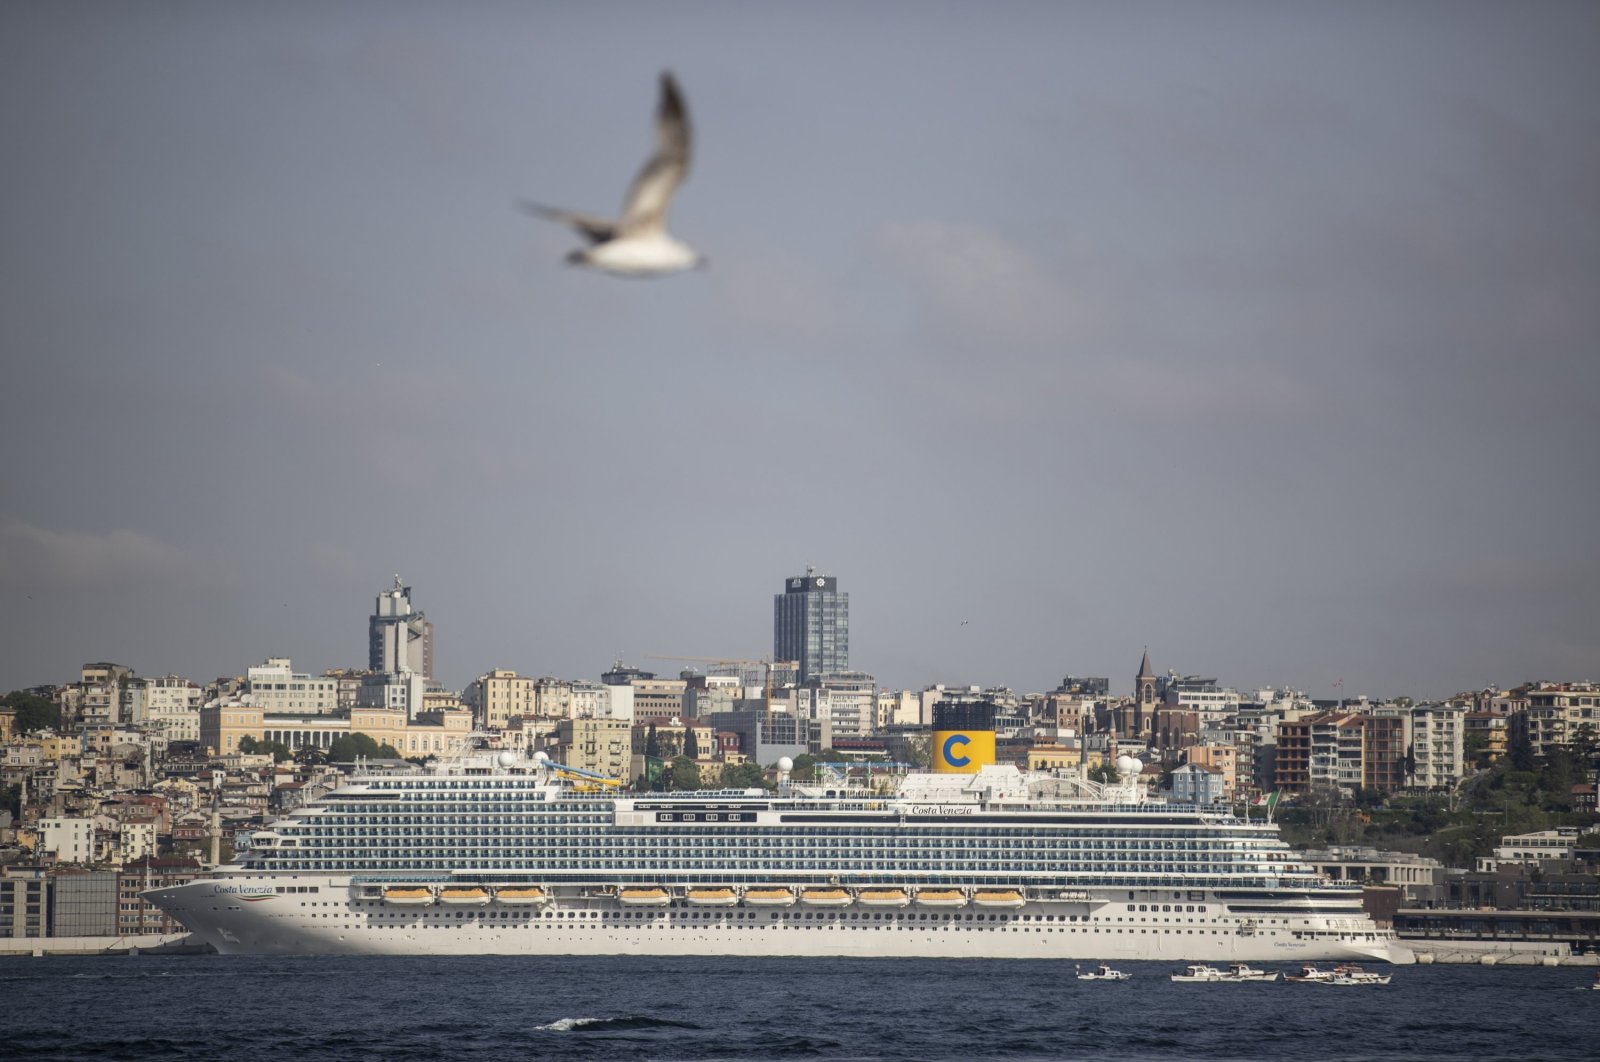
top-left (0, 955), bottom-right (1600, 1062)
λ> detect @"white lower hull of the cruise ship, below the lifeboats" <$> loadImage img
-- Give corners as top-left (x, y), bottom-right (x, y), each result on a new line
top-left (147, 876), bottom-right (1413, 963)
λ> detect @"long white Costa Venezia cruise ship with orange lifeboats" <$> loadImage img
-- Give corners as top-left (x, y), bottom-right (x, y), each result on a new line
top-left (144, 733), bottom-right (1413, 963)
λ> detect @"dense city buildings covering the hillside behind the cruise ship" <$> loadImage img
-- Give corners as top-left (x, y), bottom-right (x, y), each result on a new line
top-left (0, 569), bottom-right (1600, 953)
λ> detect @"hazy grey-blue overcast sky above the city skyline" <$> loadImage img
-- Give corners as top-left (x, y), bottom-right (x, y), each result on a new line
top-left (0, 2), bottom-right (1600, 697)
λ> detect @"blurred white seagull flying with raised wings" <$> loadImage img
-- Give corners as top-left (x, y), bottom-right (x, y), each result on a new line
top-left (522, 72), bottom-right (706, 277)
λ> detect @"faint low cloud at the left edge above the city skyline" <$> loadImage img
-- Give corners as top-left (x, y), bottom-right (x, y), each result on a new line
top-left (0, 518), bottom-right (219, 590)
